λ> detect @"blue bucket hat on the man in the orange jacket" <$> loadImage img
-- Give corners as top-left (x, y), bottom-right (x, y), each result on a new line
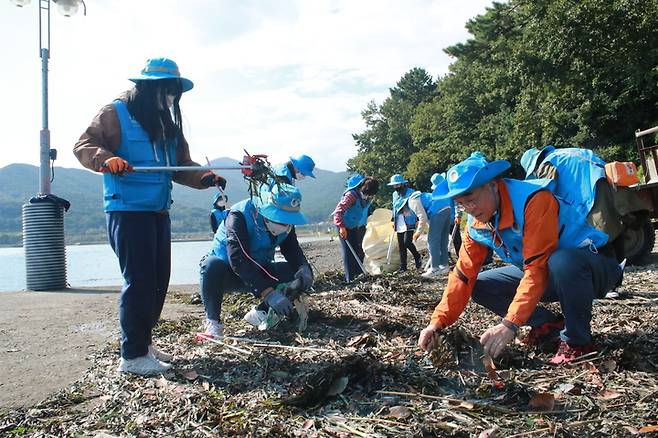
top-left (432, 151), bottom-right (510, 199)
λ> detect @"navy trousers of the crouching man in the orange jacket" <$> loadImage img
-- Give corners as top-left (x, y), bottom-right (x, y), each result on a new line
top-left (472, 248), bottom-right (622, 345)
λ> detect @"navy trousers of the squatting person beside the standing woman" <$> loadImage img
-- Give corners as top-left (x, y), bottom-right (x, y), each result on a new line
top-left (199, 256), bottom-right (295, 321)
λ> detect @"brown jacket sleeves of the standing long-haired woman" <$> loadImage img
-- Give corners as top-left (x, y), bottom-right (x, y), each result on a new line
top-left (73, 93), bottom-right (206, 189)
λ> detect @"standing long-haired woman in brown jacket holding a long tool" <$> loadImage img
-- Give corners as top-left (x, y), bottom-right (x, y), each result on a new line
top-left (73, 58), bottom-right (226, 375)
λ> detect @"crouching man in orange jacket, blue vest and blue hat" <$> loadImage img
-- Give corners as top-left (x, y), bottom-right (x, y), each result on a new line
top-left (418, 152), bottom-right (622, 364)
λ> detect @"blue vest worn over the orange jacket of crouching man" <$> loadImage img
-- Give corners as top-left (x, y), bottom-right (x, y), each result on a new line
top-left (468, 179), bottom-right (608, 269)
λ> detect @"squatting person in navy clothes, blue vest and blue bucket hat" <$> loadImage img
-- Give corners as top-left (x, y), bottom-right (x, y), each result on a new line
top-left (200, 184), bottom-right (313, 337)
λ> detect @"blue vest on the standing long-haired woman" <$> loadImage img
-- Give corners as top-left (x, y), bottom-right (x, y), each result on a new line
top-left (103, 100), bottom-right (177, 212)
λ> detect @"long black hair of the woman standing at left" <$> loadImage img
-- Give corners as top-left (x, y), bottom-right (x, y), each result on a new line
top-left (126, 78), bottom-right (183, 143)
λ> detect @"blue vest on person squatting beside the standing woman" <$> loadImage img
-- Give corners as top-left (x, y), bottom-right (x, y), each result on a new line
top-left (208, 199), bottom-right (288, 265)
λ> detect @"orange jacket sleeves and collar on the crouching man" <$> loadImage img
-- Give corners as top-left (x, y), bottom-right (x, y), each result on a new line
top-left (430, 179), bottom-right (559, 328)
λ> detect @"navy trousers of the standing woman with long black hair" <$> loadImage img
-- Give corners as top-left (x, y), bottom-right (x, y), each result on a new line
top-left (106, 211), bottom-right (171, 359)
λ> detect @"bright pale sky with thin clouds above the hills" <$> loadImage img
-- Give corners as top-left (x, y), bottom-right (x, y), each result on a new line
top-left (0, 0), bottom-right (491, 171)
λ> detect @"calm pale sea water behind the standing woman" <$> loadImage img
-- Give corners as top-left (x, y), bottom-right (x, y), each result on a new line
top-left (0, 237), bottom-right (328, 292)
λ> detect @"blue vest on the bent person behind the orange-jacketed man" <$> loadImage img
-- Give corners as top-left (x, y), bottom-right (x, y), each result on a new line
top-left (537, 148), bottom-right (606, 216)
